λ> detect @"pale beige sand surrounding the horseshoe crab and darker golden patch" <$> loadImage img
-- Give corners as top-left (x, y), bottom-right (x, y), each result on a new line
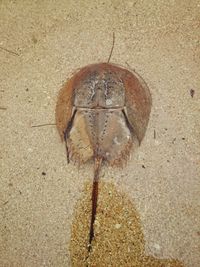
top-left (0, 0), bottom-right (200, 267)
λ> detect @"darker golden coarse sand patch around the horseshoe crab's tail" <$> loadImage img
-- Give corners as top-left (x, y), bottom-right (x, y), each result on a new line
top-left (70, 181), bottom-right (184, 267)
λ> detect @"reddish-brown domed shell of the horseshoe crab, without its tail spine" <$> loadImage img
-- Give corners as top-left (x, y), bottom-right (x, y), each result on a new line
top-left (56, 63), bottom-right (151, 165)
